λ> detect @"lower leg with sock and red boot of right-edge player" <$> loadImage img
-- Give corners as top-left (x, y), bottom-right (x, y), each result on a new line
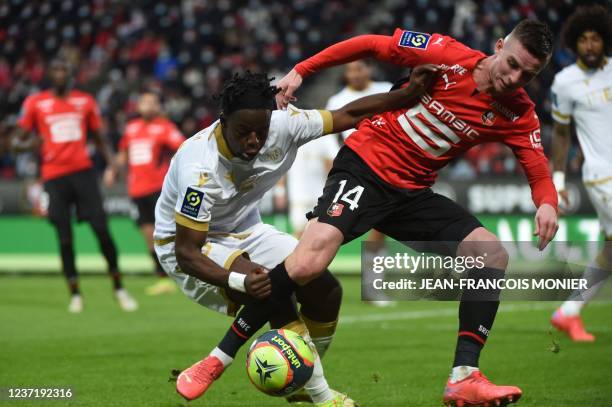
top-left (551, 236), bottom-right (612, 342)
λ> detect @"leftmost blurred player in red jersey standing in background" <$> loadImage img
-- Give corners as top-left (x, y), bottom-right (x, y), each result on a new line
top-left (14, 58), bottom-right (138, 313)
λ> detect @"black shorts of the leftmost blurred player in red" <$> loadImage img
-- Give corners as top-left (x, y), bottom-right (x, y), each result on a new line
top-left (45, 169), bottom-right (106, 223)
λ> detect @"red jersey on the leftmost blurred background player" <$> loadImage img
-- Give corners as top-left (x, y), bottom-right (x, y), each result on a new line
top-left (18, 90), bottom-right (102, 181)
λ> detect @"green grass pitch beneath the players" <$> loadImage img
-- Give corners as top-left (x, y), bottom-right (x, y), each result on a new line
top-left (0, 276), bottom-right (612, 407)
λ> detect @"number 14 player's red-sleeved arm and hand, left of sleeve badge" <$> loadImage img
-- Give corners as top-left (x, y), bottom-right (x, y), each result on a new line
top-left (276, 35), bottom-right (393, 109)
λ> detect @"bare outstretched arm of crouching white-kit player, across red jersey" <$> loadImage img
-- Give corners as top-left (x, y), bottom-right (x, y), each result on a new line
top-left (331, 64), bottom-right (439, 133)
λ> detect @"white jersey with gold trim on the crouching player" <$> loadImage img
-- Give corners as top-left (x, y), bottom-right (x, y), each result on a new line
top-left (154, 106), bottom-right (332, 240)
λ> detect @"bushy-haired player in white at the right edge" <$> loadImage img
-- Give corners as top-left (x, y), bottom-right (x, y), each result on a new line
top-left (551, 6), bottom-right (612, 342)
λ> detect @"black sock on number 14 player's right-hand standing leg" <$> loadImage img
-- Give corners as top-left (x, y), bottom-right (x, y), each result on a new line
top-left (453, 267), bottom-right (504, 367)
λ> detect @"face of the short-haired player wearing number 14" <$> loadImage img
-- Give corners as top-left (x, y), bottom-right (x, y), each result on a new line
top-left (489, 37), bottom-right (548, 94)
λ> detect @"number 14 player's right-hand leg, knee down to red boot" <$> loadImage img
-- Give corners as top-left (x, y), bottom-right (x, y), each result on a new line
top-left (443, 227), bottom-right (522, 406)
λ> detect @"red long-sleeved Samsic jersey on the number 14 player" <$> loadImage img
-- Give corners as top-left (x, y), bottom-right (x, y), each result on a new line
top-left (296, 29), bottom-right (557, 208)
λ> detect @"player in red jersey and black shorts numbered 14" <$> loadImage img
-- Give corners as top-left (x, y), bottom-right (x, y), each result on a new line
top-left (203, 20), bottom-right (558, 406)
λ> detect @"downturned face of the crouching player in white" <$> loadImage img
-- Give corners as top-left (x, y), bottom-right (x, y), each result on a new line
top-left (222, 109), bottom-right (272, 161)
